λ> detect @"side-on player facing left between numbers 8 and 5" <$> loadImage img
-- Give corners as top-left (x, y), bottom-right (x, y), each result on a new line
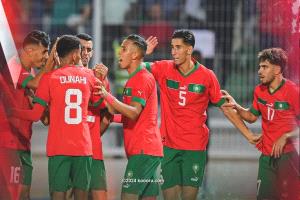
top-left (97, 34), bottom-right (163, 200)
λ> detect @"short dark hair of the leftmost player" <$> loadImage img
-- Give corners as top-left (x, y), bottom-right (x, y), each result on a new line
top-left (23, 30), bottom-right (50, 48)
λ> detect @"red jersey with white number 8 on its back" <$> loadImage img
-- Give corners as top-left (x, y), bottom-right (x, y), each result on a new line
top-left (34, 66), bottom-right (95, 156)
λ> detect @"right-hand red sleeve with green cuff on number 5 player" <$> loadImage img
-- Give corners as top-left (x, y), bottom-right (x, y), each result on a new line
top-left (208, 70), bottom-right (225, 107)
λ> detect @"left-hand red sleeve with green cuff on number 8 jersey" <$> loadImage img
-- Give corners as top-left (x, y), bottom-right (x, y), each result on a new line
top-left (33, 74), bottom-right (50, 107)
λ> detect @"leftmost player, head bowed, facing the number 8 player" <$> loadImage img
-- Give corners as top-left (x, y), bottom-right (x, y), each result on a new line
top-left (8, 30), bottom-right (53, 200)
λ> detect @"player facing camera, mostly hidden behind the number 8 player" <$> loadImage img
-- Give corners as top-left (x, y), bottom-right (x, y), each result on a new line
top-left (76, 33), bottom-right (110, 200)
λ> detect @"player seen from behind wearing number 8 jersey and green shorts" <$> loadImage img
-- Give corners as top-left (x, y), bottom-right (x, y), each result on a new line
top-left (13, 35), bottom-right (97, 199)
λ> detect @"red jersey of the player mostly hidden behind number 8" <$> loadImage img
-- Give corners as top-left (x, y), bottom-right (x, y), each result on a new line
top-left (87, 79), bottom-right (110, 160)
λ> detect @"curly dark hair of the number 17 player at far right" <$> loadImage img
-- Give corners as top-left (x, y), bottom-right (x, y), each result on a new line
top-left (257, 48), bottom-right (288, 72)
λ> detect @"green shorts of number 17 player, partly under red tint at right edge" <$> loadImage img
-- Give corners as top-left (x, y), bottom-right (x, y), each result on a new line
top-left (257, 152), bottom-right (299, 200)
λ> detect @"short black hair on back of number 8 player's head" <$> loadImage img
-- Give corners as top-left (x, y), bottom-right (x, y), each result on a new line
top-left (56, 35), bottom-right (80, 58)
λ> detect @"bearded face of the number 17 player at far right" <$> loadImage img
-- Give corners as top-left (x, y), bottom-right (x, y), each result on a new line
top-left (258, 60), bottom-right (279, 85)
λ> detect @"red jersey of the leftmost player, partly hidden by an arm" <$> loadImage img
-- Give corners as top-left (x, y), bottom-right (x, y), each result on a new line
top-left (8, 57), bottom-right (33, 150)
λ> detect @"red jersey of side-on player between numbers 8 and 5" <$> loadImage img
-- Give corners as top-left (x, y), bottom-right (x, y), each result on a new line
top-left (122, 66), bottom-right (163, 157)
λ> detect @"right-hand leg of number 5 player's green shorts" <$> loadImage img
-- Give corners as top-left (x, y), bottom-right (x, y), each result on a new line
top-left (182, 151), bottom-right (206, 188)
